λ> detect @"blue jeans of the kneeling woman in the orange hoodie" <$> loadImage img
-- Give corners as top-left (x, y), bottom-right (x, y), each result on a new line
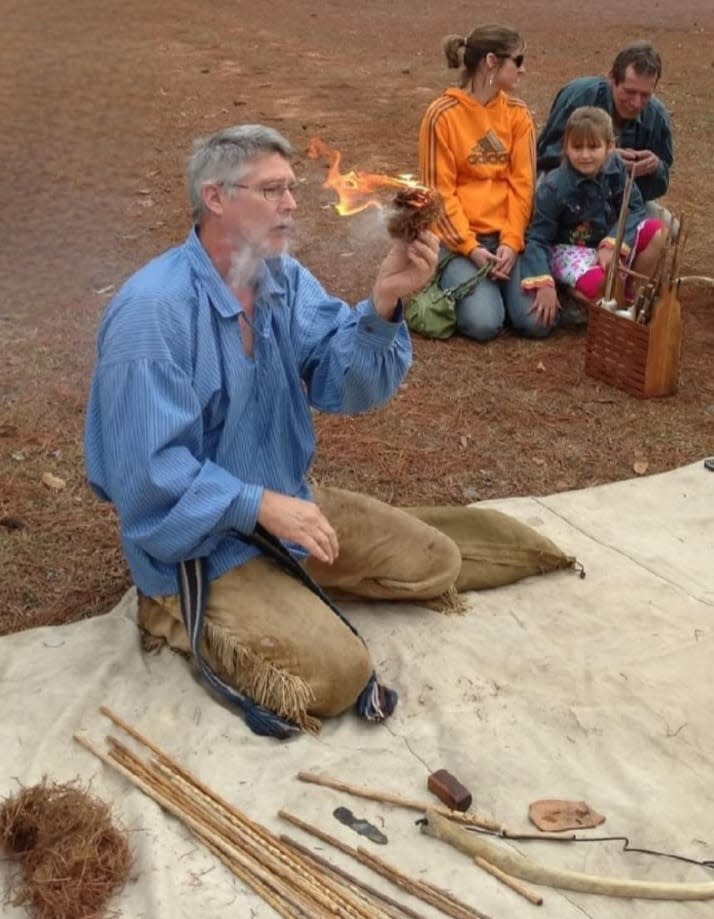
top-left (439, 236), bottom-right (552, 341)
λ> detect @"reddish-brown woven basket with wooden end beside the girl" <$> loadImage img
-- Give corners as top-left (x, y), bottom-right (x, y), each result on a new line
top-left (585, 289), bottom-right (682, 399)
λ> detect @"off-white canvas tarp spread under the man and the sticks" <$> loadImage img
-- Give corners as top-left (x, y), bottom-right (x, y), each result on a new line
top-left (0, 462), bottom-right (714, 919)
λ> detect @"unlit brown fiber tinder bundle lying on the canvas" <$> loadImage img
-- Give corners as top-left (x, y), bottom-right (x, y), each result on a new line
top-left (0, 778), bottom-right (131, 919)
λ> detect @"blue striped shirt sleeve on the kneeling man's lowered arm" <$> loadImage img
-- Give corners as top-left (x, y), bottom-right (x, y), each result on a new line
top-left (88, 359), bottom-right (263, 563)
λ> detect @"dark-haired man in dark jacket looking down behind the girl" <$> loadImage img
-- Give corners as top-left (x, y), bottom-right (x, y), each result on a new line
top-left (536, 41), bottom-right (674, 207)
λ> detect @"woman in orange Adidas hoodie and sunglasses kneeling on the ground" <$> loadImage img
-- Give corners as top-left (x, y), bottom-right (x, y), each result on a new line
top-left (419, 25), bottom-right (550, 341)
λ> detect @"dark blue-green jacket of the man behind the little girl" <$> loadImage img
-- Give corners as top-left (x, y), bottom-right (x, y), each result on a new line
top-left (536, 77), bottom-right (674, 201)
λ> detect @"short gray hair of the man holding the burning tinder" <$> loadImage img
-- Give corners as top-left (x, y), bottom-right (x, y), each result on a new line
top-left (188, 124), bottom-right (293, 223)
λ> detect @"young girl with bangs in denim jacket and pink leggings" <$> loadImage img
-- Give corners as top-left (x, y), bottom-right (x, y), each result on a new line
top-left (521, 106), bottom-right (664, 326)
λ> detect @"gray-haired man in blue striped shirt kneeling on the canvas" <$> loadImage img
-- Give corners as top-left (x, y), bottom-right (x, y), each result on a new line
top-left (85, 125), bottom-right (461, 736)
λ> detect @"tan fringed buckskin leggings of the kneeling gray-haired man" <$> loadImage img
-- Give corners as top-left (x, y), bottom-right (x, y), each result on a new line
top-left (139, 487), bottom-right (461, 731)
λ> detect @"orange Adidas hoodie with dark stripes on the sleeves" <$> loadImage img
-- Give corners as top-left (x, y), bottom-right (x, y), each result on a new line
top-left (419, 88), bottom-right (535, 256)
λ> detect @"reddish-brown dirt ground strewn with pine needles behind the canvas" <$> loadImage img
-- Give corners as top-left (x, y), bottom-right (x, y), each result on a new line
top-left (0, 0), bottom-right (714, 633)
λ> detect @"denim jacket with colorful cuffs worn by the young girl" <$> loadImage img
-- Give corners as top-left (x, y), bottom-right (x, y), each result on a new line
top-left (521, 154), bottom-right (646, 290)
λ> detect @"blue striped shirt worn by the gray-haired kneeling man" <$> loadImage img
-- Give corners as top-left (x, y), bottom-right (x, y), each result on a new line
top-left (85, 229), bottom-right (411, 596)
